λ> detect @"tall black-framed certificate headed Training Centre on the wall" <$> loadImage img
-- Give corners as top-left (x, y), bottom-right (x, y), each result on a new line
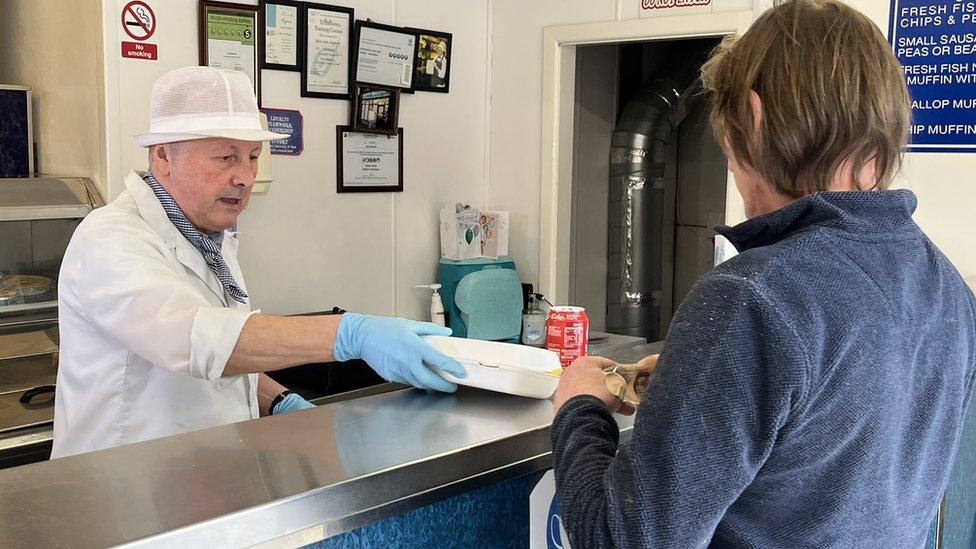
top-left (301, 2), bottom-right (356, 99)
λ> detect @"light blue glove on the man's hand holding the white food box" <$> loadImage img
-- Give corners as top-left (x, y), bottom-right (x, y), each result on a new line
top-left (332, 313), bottom-right (467, 393)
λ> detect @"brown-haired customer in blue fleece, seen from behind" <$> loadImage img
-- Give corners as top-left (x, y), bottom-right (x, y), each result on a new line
top-left (552, 0), bottom-right (976, 549)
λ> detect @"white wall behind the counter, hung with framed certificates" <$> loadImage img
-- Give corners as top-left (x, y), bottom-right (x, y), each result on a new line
top-left (42, 0), bottom-right (976, 324)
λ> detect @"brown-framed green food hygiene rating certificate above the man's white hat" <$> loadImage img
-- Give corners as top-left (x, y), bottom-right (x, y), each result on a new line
top-left (199, 0), bottom-right (261, 105)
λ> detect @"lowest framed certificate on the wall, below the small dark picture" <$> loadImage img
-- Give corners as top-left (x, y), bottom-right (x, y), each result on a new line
top-left (342, 131), bottom-right (400, 187)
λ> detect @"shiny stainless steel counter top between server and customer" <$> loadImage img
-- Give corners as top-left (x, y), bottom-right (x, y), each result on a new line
top-left (0, 340), bottom-right (664, 547)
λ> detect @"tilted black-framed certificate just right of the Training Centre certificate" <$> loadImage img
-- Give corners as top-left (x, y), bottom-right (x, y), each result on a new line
top-left (355, 21), bottom-right (417, 93)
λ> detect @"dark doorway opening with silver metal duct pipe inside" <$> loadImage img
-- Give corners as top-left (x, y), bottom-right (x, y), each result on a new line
top-left (568, 38), bottom-right (728, 341)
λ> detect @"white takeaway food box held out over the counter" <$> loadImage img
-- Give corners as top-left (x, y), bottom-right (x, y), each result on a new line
top-left (423, 336), bottom-right (559, 398)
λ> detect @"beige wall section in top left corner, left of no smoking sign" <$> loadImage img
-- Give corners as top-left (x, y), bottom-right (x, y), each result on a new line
top-left (0, 0), bottom-right (106, 193)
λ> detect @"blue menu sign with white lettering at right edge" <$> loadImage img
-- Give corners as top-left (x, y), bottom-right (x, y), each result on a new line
top-left (888, 0), bottom-right (976, 152)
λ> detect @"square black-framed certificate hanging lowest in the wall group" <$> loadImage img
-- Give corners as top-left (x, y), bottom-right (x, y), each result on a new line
top-left (336, 126), bottom-right (403, 193)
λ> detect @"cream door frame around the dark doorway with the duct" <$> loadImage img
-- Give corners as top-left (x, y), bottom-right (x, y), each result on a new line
top-left (539, 10), bottom-right (755, 303)
